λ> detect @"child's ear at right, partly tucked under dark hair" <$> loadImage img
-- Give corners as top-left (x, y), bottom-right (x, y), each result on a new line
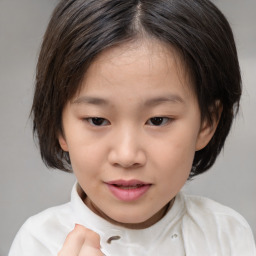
top-left (196, 101), bottom-right (222, 151)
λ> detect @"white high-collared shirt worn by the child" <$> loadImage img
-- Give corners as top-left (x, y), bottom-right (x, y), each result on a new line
top-left (9, 183), bottom-right (256, 256)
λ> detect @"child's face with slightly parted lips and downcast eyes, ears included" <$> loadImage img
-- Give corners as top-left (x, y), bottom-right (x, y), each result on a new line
top-left (59, 41), bottom-right (213, 228)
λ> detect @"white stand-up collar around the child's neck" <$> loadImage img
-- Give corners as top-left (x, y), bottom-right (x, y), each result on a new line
top-left (71, 183), bottom-right (184, 251)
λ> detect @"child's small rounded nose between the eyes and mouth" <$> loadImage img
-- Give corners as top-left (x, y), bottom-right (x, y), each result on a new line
top-left (108, 128), bottom-right (146, 169)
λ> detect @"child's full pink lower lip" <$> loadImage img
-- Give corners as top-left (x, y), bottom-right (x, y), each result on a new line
top-left (108, 184), bottom-right (151, 202)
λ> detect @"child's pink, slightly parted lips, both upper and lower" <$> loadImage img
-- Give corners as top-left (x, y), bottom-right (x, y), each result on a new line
top-left (106, 180), bottom-right (152, 202)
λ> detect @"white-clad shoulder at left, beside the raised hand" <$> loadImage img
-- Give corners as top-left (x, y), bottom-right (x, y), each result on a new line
top-left (9, 203), bottom-right (73, 256)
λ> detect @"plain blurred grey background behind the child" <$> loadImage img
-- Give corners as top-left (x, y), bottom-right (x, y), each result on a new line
top-left (0, 0), bottom-right (256, 256)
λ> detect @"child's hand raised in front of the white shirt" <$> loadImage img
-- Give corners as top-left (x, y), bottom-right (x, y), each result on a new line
top-left (58, 224), bottom-right (104, 256)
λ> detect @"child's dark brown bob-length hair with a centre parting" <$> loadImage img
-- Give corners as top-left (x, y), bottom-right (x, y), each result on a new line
top-left (31, 0), bottom-right (241, 178)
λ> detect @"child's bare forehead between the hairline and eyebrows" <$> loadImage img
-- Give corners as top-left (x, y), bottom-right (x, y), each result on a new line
top-left (76, 39), bottom-right (194, 100)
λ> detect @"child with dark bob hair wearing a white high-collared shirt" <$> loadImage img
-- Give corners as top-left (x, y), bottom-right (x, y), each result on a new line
top-left (9, 0), bottom-right (256, 256)
